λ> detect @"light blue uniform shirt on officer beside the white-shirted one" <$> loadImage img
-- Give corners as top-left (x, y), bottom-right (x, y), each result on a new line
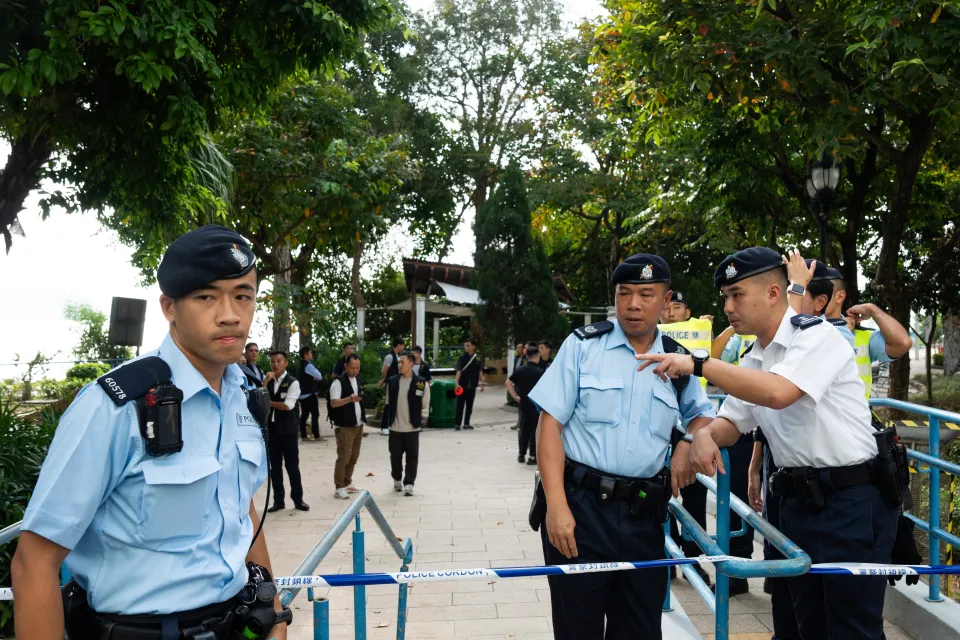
top-left (530, 321), bottom-right (716, 478)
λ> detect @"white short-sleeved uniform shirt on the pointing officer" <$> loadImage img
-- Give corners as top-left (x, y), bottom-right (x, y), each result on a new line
top-left (717, 308), bottom-right (877, 469)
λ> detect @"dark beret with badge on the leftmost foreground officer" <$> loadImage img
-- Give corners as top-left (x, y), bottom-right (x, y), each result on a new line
top-left (157, 224), bottom-right (256, 298)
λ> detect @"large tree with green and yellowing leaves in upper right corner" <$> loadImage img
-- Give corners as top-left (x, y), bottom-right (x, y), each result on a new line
top-left (595, 0), bottom-right (960, 398)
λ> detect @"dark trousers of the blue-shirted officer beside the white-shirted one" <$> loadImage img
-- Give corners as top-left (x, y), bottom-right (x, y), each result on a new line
top-left (540, 483), bottom-right (667, 640)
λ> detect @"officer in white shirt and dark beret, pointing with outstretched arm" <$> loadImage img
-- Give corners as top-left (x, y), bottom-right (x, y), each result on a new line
top-left (638, 247), bottom-right (898, 638)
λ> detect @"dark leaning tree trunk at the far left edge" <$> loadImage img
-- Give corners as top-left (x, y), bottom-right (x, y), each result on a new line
top-left (0, 135), bottom-right (53, 253)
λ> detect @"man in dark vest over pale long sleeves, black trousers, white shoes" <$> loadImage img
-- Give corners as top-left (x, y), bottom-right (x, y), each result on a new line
top-left (384, 351), bottom-right (430, 496)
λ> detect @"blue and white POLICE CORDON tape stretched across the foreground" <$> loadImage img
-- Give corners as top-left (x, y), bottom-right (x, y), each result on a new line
top-left (0, 556), bottom-right (960, 600)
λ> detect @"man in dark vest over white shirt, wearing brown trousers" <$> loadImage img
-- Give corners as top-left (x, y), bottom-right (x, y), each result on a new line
top-left (329, 353), bottom-right (364, 500)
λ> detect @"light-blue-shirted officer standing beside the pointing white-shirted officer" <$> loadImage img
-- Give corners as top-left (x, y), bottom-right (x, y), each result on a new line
top-left (529, 254), bottom-right (715, 640)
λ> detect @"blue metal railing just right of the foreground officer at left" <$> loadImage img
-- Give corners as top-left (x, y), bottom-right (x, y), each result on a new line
top-left (280, 490), bottom-right (413, 640)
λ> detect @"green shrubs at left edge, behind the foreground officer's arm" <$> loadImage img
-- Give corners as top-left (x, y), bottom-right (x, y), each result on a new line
top-left (0, 397), bottom-right (60, 637)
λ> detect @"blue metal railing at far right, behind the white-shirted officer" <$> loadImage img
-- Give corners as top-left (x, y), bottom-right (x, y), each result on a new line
top-left (870, 398), bottom-right (960, 602)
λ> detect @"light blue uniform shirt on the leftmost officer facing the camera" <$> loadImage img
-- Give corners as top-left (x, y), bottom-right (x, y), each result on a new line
top-left (22, 335), bottom-right (267, 615)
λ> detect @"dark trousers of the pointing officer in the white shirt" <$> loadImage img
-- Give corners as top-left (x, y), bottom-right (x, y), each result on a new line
top-left (780, 476), bottom-right (898, 640)
